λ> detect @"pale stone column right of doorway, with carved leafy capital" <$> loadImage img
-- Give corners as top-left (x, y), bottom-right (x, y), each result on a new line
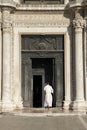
top-left (73, 12), bottom-right (85, 108)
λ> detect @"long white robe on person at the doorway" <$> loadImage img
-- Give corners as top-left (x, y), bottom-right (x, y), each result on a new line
top-left (44, 84), bottom-right (53, 107)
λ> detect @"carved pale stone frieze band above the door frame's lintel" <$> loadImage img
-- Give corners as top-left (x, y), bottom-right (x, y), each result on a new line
top-left (14, 14), bottom-right (70, 27)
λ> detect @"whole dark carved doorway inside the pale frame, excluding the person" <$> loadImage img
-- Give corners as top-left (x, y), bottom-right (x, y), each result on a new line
top-left (22, 35), bottom-right (65, 107)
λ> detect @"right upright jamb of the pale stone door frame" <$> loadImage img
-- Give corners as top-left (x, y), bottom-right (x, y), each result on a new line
top-left (64, 32), bottom-right (71, 109)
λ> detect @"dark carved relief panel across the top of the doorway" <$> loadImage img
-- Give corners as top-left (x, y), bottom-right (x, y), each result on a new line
top-left (22, 35), bottom-right (64, 50)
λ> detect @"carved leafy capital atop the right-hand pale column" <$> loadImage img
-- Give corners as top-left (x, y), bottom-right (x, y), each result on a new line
top-left (73, 12), bottom-right (86, 29)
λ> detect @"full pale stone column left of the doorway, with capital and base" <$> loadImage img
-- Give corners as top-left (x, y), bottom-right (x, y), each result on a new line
top-left (2, 8), bottom-right (12, 110)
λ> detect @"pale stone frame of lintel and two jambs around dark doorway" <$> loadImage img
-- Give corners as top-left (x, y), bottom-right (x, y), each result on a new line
top-left (12, 27), bottom-right (71, 108)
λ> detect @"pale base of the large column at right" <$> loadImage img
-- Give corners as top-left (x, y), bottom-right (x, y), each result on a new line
top-left (73, 100), bottom-right (86, 110)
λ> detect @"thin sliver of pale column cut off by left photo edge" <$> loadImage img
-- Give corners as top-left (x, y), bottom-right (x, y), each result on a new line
top-left (0, 9), bottom-right (2, 107)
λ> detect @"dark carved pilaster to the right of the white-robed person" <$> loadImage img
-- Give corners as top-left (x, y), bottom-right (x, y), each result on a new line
top-left (55, 55), bottom-right (64, 107)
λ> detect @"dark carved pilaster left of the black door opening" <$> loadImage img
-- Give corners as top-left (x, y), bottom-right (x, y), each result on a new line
top-left (22, 55), bottom-right (33, 107)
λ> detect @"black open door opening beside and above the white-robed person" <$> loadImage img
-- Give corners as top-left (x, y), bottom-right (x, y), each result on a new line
top-left (31, 58), bottom-right (54, 107)
